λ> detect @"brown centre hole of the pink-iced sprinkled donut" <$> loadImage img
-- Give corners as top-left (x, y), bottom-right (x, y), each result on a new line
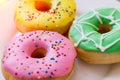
top-left (31, 48), bottom-right (47, 58)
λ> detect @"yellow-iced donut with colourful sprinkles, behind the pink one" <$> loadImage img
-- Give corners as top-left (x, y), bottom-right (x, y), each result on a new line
top-left (15, 0), bottom-right (76, 34)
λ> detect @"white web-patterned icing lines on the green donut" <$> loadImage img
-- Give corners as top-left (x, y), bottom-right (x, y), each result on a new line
top-left (74, 9), bottom-right (120, 52)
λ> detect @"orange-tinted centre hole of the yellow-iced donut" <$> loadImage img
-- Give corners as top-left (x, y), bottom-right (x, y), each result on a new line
top-left (35, 0), bottom-right (51, 12)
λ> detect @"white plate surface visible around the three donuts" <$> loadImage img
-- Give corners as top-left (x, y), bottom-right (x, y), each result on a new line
top-left (0, 0), bottom-right (120, 80)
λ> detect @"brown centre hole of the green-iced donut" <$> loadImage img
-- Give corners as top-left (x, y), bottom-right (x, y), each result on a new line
top-left (98, 24), bottom-right (112, 34)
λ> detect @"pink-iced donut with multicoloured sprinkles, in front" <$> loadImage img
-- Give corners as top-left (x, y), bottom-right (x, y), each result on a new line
top-left (2, 30), bottom-right (76, 80)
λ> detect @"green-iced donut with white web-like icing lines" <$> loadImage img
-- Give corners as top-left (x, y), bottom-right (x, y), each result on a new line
top-left (69, 8), bottom-right (120, 64)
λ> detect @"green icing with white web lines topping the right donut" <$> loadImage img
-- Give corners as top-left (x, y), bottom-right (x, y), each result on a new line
top-left (70, 8), bottom-right (120, 53)
